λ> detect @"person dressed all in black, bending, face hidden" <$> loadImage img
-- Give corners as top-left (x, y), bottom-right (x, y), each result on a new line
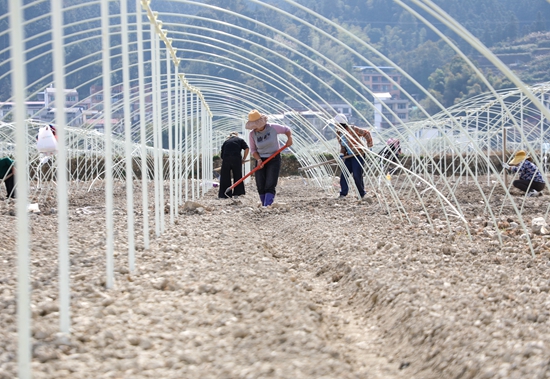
top-left (218, 132), bottom-right (249, 199)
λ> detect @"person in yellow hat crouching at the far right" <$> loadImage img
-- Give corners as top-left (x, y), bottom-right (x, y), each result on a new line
top-left (502, 150), bottom-right (546, 197)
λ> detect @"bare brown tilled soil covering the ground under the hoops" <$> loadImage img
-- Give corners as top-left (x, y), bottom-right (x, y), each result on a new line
top-left (0, 178), bottom-right (550, 379)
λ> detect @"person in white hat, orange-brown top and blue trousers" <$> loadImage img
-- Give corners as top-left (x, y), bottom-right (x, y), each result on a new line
top-left (334, 114), bottom-right (373, 199)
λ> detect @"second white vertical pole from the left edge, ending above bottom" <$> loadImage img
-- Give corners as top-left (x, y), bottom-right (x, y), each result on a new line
top-left (52, 1), bottom-right (71, 334)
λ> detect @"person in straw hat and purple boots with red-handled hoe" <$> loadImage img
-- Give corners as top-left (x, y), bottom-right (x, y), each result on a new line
top-left (245, 110), bottom-right (292, 207)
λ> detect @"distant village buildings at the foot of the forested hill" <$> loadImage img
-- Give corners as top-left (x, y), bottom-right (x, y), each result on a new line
top-left (0, 66), bottom-right (410, 141)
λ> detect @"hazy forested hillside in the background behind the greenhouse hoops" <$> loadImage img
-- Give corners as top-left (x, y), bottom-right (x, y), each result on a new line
top-left (0, 0), bottom-right (550, 116)
